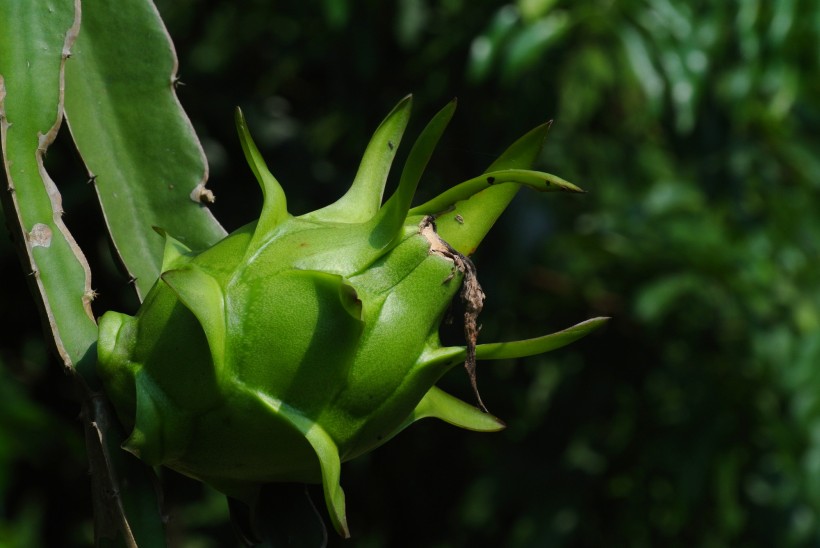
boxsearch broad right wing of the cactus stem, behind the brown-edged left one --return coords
[65,0,225,299]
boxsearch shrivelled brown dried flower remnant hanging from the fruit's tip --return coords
[419,215,489,413]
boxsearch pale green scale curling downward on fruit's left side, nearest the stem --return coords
[160,267,227,372]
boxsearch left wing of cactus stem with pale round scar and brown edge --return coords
[0,1,92,371]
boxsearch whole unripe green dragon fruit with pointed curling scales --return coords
[98,97,608,536]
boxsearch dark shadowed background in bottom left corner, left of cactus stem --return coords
[0,230,91,548]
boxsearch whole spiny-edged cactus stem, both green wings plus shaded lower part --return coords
[0,0,232,546]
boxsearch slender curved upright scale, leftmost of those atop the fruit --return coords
[235,107,289,248]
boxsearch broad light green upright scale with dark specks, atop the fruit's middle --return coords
[303,95,413,223]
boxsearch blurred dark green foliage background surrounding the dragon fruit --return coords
[0,0,820,547]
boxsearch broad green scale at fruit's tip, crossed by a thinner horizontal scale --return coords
[436,123,550,255]
